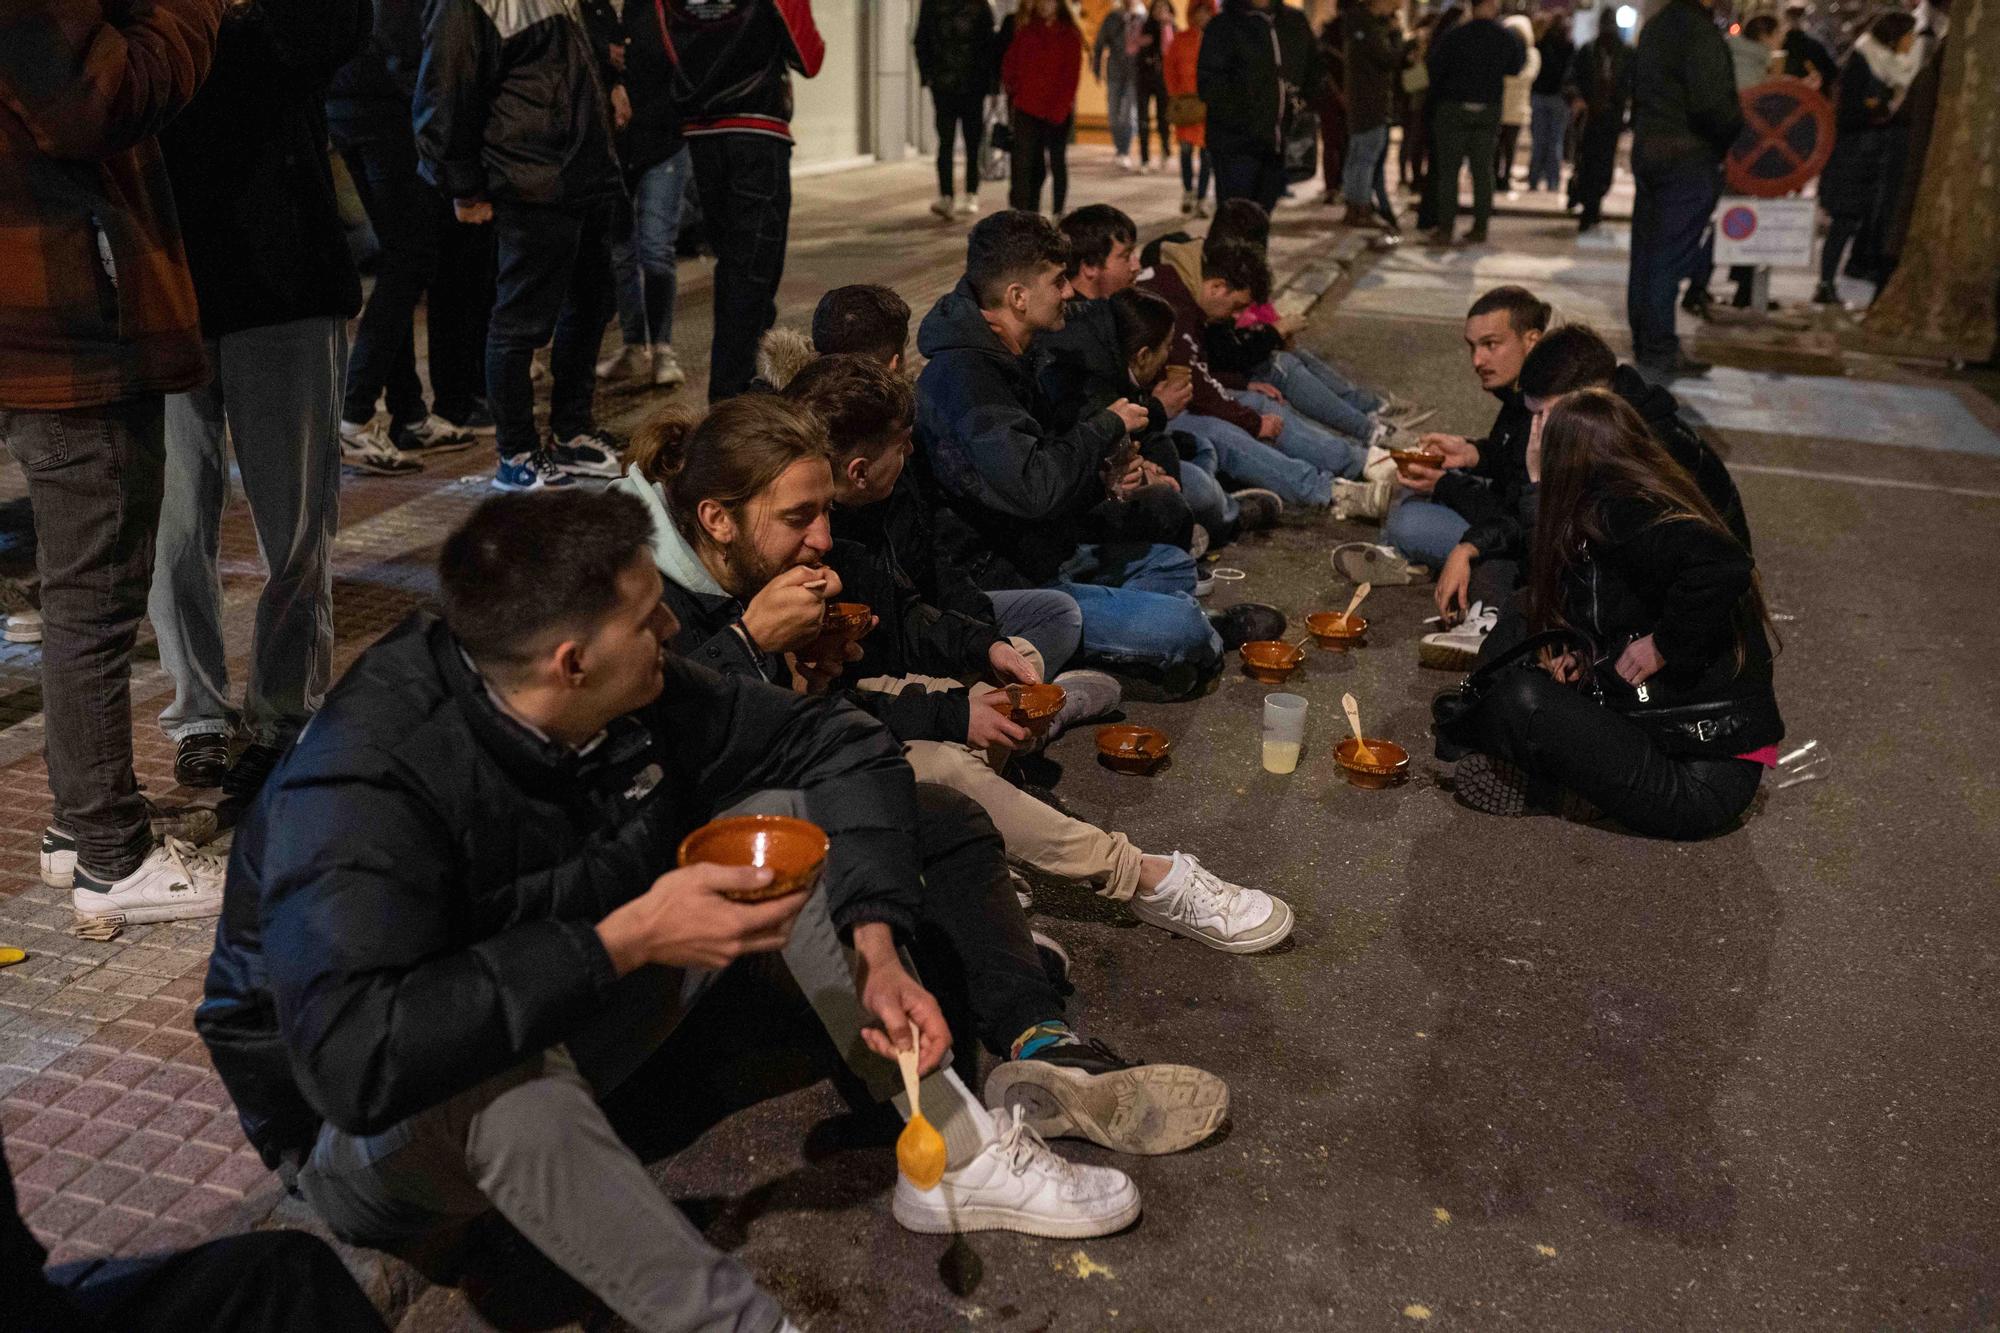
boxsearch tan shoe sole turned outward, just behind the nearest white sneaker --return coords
[986,1061,1230,1157]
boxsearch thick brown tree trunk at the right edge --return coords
[1862,0,2000,360]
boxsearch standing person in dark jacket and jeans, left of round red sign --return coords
[1626,0,1744,376]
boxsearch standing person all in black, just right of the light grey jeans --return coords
[326,0,494,474]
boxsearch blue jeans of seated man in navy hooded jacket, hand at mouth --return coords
[1048,544,1222,671]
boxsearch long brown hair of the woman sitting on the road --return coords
[1528,388,1778,671]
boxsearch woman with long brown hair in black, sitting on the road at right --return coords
[1454,388,1784,839]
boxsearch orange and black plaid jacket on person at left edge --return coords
[0,0,224,410]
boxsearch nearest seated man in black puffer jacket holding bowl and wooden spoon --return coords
[207,490,1186,1333]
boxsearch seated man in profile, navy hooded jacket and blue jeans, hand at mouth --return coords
[916,210,1222,697]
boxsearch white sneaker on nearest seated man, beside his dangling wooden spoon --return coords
[890,1107,1140,1241]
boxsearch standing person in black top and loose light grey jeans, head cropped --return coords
[148,0,370,799]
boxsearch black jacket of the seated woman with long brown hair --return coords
[1562,498,1784,759]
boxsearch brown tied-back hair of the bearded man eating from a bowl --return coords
[626,394,832,546]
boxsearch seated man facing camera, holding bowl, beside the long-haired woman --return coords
[1334,286,1550,671]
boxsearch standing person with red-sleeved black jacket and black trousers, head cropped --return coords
[664,0,826,402]
